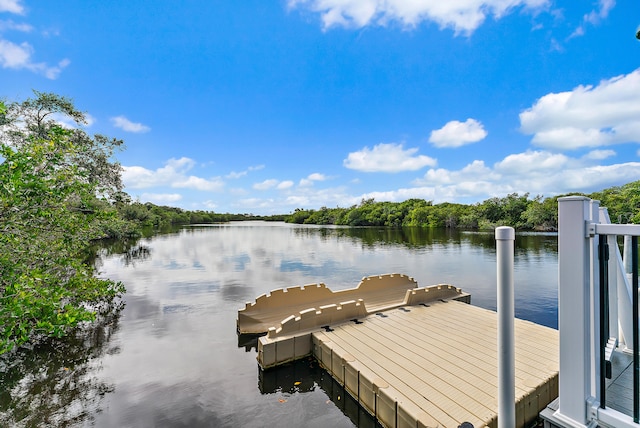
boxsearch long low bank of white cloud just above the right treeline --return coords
[225,150,640,213]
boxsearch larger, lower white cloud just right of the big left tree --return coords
[122,157,224,192]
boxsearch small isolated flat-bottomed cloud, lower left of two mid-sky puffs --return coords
[343,143,437,172]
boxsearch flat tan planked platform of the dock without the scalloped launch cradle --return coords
[312,301,558,428]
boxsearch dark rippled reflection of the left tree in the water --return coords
[0,303,124,427]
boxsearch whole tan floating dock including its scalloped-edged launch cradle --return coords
[238,274,559,428]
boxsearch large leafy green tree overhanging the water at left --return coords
[0,93,128,354]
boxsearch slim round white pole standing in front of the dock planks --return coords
[496,226,516,427]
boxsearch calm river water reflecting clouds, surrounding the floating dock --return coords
[0,222,557,428]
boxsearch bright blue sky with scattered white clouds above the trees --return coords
[0,0,640,214]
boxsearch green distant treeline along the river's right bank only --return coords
[286,181,640,231]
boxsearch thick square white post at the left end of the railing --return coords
[557,196,592,425]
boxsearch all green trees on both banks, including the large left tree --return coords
[0,91,640,355]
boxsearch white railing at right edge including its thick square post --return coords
[553,196,640,427]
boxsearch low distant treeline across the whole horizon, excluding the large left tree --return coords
[105,180,640,231]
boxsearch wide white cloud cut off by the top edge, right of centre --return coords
[288,0,549,34]
